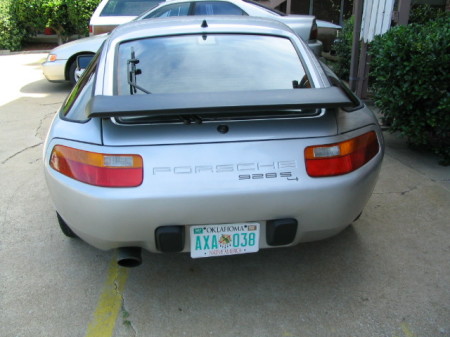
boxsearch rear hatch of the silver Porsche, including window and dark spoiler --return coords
[88,31,353,146]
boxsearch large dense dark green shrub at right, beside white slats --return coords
[370,14,450,165]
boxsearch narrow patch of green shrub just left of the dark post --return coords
[332,17,355,80]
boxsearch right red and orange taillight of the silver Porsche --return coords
[305,131,380,177]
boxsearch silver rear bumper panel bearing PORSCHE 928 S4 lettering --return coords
[45,127,383,252]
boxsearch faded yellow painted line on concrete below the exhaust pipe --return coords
[85,257,128,337]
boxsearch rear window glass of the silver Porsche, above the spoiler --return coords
[116,34,306,95]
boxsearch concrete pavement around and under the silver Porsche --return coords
[0,54,450,337]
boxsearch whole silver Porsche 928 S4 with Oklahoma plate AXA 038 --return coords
[44,16,384,267]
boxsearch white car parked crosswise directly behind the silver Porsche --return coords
[42,0,322,83]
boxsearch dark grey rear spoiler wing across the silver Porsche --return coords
[86,87,354,118]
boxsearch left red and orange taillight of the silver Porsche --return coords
[50,145,144,187]
